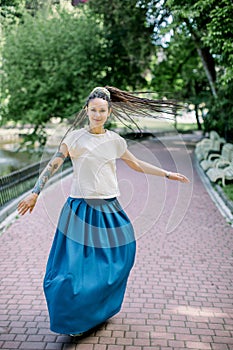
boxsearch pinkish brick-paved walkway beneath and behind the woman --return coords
[0,138,233,350]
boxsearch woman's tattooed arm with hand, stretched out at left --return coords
[18,143,69,215]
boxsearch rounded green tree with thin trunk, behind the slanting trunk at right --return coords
[151,31,209,130]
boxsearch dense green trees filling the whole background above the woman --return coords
[1,0,233,144]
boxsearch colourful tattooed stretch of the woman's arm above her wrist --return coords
[32,152,66,194]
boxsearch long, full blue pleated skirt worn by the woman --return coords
[44,197,136,334]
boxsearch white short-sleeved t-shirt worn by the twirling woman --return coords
[62,128,127,198]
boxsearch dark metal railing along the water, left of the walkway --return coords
[0,159,71,207]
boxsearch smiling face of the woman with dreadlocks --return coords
[87,98,111,128]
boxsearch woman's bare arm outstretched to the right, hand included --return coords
[121,150,190,183]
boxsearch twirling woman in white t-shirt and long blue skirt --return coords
[18,87,189,336]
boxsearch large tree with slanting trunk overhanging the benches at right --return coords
[140,0,233,140]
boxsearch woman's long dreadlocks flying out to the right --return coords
[61,86,181,143]
